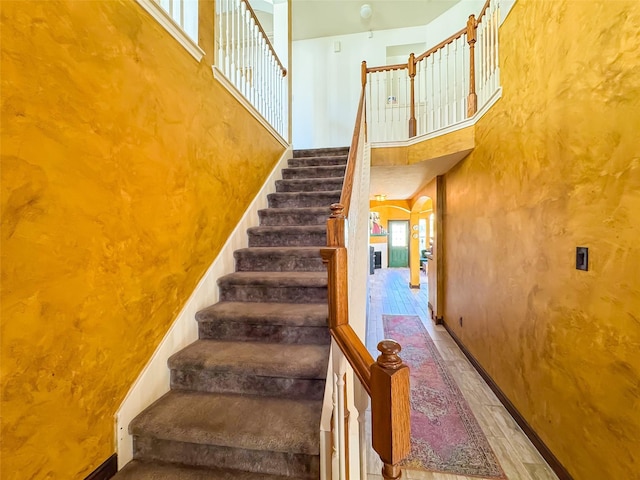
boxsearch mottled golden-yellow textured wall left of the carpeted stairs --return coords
[0,0,284,480]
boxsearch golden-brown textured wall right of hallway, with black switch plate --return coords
[445,0,640,480]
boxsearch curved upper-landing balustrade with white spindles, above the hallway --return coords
[366,0,500,142]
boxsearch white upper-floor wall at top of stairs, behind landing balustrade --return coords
[292,0,514,148]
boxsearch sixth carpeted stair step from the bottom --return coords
[233,247,325,272]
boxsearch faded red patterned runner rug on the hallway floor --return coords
[382,315,506,479]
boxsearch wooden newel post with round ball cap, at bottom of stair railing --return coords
[371,340,411,480]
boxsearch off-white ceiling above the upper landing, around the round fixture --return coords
[291,0,460,40]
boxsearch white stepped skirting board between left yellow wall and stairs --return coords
[115,148,292,469]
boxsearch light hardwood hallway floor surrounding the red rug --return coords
[366,268,558,480]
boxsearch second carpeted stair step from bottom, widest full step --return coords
[129,391,322,479]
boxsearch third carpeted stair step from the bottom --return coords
[169,340,329,400]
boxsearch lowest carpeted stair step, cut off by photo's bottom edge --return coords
[113,460,291,480]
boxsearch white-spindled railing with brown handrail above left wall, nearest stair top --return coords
[215,0,289,139]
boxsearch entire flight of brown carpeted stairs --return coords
[114,148,348,480]
